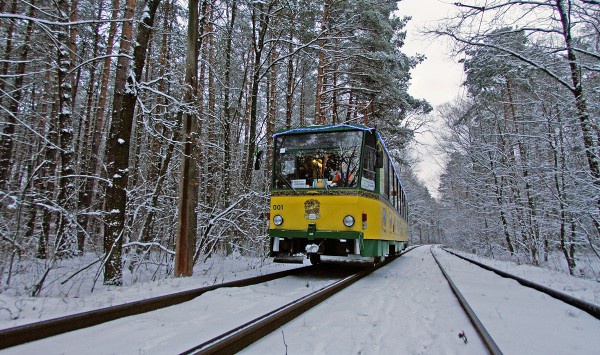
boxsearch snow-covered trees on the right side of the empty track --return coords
[433,0,600,279]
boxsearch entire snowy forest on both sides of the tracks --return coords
[0,0,600,296]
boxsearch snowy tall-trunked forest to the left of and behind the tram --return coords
[0,0,430,294]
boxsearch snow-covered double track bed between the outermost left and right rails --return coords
[0,247,600,354]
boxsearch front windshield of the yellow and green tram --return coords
[273,131,363,189]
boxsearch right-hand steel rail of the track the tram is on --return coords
[182,247,415,355]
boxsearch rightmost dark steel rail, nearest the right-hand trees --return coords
[442,248,600,319]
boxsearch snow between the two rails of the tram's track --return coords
[7,276,332,354]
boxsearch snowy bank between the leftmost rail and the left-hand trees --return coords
[0,254,302,329]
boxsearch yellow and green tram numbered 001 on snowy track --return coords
[269,124,408,264]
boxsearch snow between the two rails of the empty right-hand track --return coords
[434,248,600,354]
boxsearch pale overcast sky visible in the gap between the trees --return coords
[398,0,463,196]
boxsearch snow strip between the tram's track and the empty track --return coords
[243,247,487,354]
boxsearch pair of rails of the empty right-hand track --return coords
[430,247,600,354]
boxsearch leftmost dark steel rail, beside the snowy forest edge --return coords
[0,266,315,349]
